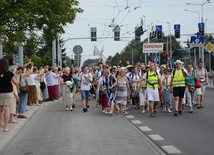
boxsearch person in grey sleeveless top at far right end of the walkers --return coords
[194,60,209,109]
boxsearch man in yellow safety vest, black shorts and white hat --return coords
[170,60,187,116]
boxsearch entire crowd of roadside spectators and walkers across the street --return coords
[0,58,208,131]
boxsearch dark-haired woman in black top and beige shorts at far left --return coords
[0,58,19,132]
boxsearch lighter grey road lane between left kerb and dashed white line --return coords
[0,95,164,155]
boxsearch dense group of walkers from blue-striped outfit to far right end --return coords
[89,60,209,117]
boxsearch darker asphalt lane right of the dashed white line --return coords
[123,88,214,155]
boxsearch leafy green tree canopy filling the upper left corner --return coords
[0,0,83,43]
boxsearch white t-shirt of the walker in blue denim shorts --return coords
[78,73,92,90]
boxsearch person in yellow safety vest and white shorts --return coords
[143,63,162,117]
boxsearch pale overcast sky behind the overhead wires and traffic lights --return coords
[61,0,214,61]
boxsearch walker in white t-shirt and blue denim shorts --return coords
[78,66,92,112]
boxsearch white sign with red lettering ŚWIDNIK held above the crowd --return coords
[143,43,163,53]
